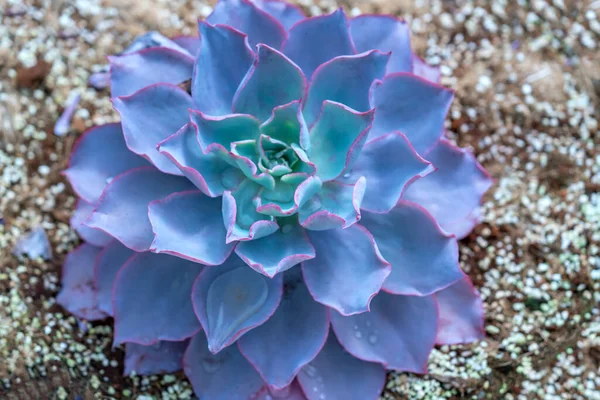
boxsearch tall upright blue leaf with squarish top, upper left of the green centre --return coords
[192,21,254,116]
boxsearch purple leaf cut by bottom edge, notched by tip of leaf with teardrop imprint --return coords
[183,330,264,400]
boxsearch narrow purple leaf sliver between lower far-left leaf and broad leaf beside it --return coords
[94,240,136,317]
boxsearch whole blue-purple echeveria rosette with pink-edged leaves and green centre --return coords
[58,0,491,400]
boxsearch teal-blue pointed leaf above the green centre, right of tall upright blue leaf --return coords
[233,44,306,121]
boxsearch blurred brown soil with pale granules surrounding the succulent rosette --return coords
[0,0,600,400]
